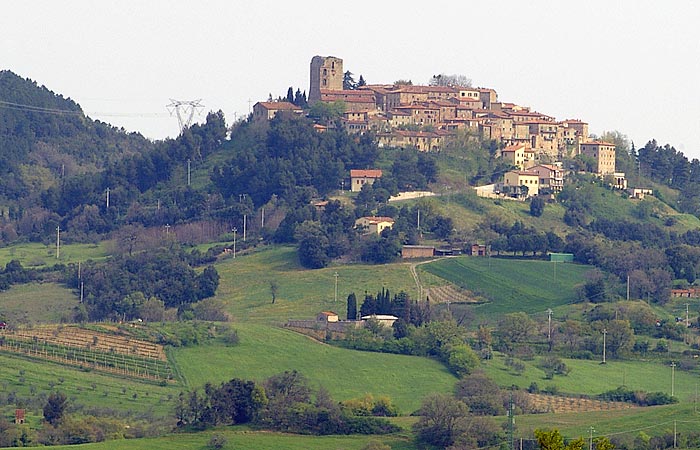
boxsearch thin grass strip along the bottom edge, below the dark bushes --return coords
[54,427,417,450]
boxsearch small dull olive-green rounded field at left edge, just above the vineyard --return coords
[0,283,79,323]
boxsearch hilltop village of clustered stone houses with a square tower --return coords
[253,56,636,199]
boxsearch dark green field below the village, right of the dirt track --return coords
[418,256,592,320]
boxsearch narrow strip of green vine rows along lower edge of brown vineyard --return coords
[0,337,173,380]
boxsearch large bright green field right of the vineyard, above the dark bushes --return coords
[171,323,457,414]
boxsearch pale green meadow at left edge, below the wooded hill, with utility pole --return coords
[0,241,112,267]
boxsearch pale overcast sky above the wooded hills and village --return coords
[0,0,700,158]
